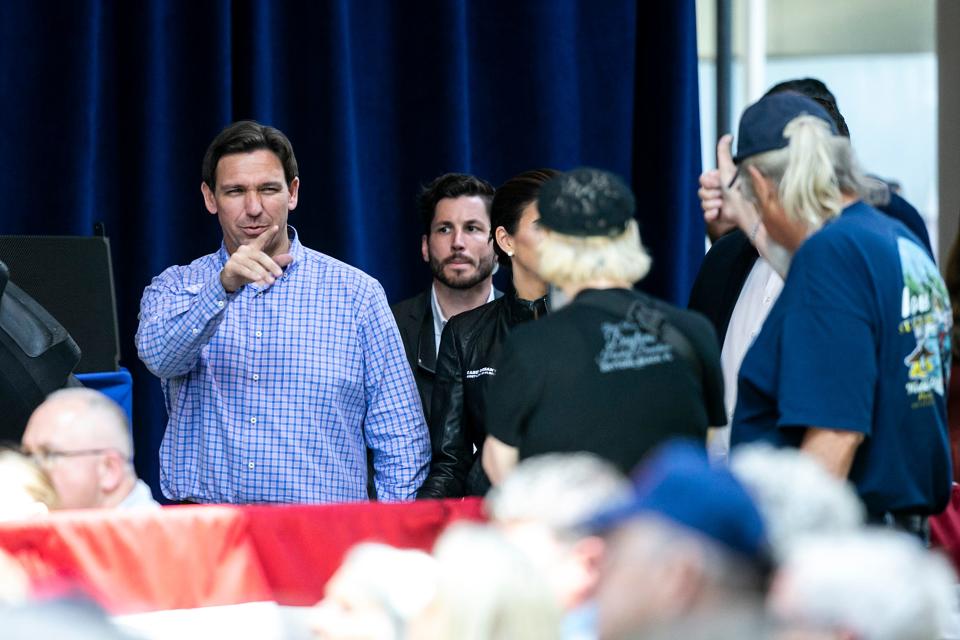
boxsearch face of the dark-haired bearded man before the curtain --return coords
[421,196,495,289]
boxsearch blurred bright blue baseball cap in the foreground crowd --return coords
[584,440,767,560]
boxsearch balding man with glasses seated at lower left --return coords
[22,388,158,509]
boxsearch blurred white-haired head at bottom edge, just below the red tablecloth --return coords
[310,543,437,640]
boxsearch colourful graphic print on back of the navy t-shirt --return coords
[897,238,953,408]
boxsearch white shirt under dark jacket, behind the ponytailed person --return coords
[708,258,783,460]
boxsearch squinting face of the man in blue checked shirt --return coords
[200,149,300,256]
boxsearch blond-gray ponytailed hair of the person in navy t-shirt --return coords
[740,114,868,230]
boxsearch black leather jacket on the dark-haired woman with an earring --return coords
[417,292,547,498]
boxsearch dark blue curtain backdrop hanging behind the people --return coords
[0,0,703,498]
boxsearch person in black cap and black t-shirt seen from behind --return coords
[483,168,726,483]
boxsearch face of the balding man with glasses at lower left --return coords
[22,407,105,509]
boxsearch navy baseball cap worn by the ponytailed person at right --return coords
[733,91,839,164]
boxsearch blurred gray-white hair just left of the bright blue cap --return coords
[486,453,630,536]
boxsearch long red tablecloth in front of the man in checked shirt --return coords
[0,499,483,613]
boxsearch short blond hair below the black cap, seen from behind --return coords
[537,220,651,287]
